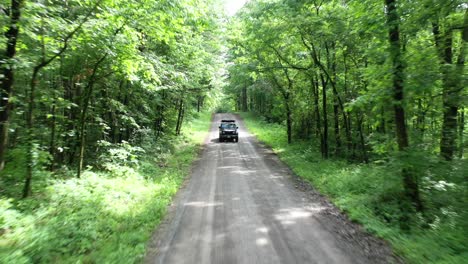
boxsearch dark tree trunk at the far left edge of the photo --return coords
[0,0,24,171]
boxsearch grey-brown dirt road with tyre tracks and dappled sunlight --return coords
[145,114,395,264]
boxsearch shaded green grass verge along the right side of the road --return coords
[240,113,468,264]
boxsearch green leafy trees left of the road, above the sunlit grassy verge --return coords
[0,0,220,197]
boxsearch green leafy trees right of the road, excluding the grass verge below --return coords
[227,0,468,225]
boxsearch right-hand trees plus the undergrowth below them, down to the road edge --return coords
[226,0,468,263]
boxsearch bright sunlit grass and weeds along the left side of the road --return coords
[0,113,211,264]
